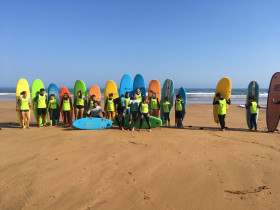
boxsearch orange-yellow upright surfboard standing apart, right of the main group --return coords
[213,77,231,123]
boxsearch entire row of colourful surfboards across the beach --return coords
[16,72,280,132]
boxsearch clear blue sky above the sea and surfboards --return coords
[0,0,280,88]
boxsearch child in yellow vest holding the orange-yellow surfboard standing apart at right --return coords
[213,93,230,131]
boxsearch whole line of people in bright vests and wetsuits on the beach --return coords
[16,88,280,131]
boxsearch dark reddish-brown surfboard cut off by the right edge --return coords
[266,72,280,132]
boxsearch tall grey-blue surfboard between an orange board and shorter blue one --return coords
[160,79,174,121]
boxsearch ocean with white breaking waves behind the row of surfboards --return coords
[0,87,268,105]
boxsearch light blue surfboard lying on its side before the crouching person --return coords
[73,117,113,130]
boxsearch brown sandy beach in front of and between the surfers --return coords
[0,102,280,210]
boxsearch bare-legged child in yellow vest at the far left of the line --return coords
[16,91,31,129]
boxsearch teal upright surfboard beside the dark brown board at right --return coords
[246,81,259,128]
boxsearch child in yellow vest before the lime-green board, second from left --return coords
[33,88,48,128]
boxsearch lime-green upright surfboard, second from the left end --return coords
[31,79,48,126]
